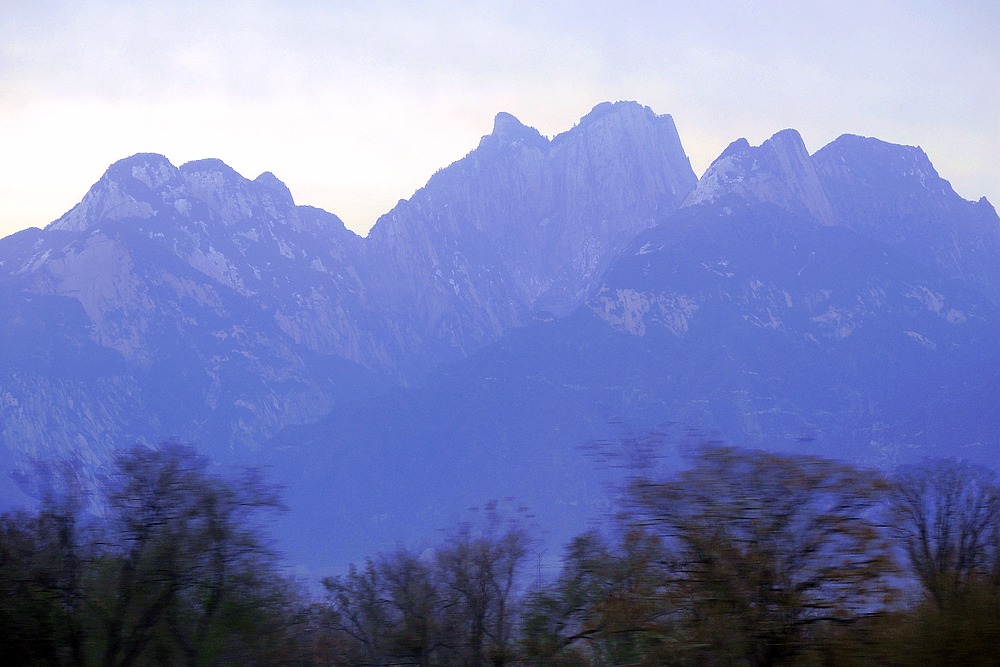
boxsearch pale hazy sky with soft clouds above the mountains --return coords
[0,0,1000,236]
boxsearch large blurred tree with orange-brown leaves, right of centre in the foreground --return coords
[630,446,894,665]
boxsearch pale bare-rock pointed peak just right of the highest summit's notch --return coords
[683,129,834,225]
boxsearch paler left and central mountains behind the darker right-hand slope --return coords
[0,103,695,458]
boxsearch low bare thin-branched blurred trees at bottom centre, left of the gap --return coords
[323,504,529,665]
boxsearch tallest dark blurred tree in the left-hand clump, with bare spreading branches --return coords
[92,443,280,667]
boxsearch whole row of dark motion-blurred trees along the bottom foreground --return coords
[0,445,1000,666]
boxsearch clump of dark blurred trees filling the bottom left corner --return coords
[0,444,290,665]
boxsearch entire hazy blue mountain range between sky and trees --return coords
[0,102,1000,568]
